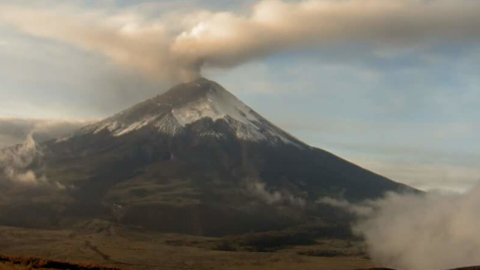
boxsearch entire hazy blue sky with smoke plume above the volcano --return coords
[0,0,480,191]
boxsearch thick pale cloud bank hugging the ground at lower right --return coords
[319,186,480,269]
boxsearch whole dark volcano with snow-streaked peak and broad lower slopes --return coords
[0,78,415,235]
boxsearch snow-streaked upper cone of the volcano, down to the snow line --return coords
[71,78,304,147]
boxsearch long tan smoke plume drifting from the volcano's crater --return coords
[0,0,480,82]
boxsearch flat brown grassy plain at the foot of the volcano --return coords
[0,222,373,270]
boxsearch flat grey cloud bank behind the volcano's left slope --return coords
[0,118,91,149]
